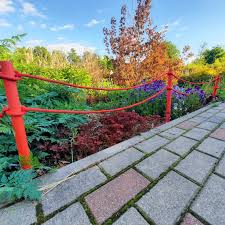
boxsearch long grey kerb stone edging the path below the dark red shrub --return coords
[39,136,145,185]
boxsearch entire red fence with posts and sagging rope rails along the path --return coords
[0,61,221,169]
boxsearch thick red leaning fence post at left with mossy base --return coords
[0,61,32,169]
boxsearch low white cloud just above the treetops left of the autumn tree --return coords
[47,42,96,55]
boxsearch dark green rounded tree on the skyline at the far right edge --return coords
[202,46,225,64]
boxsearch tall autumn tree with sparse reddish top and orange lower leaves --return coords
[103,0,183,85]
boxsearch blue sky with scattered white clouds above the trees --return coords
[0,0,225,54]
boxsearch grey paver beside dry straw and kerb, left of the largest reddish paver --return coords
[41,166,106,215]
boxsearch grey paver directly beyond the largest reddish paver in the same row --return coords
[136,149,179,179]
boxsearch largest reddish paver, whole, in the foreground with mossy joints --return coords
[85,169,149,224]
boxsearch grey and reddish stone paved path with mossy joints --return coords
[0,103,225,225]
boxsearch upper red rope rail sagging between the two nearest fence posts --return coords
[16,72,155,91]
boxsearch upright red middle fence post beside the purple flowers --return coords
[166,70,173,123]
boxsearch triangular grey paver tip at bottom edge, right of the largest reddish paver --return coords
[113,207,149,225]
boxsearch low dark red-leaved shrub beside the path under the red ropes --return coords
[75,112,163,157]
